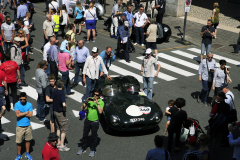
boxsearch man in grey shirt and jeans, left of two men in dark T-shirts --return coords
[35,60,48,122]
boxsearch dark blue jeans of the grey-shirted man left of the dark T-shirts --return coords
[36,93,45,121]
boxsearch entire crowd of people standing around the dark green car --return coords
[0,0,240,160]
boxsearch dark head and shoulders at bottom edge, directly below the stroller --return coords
[183,136,203,160]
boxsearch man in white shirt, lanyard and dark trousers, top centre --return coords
[132,6,148,46]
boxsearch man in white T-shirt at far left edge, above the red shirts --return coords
[1,16,15,53]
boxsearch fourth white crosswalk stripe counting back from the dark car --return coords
[158,53,199,70]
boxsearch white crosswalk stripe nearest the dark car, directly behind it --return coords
[111,64,157,84]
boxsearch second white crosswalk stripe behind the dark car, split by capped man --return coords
[119,60,177,81]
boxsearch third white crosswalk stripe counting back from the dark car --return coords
[137,56,195,77]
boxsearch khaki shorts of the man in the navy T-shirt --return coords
[54,111,68,133]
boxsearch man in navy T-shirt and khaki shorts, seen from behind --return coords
[52,80,70,151]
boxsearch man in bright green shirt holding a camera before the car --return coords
[77,88,104,157]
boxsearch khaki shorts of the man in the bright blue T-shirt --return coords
[16,125,32,143]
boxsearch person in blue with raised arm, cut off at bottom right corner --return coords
[228,122,240,160]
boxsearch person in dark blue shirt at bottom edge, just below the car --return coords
[146,135,171,160]
